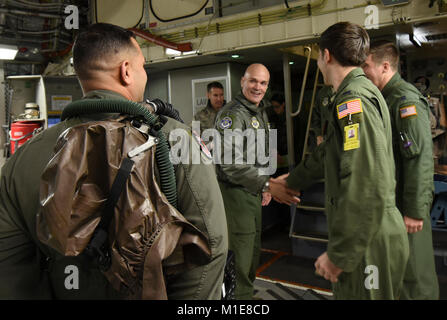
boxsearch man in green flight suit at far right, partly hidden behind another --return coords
[363,40,439,300]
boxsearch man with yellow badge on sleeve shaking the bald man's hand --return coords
[274,22,409,299]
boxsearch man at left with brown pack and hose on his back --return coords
[0,23,228,299]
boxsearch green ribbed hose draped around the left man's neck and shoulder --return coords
[61,99,177,208]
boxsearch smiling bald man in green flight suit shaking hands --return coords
[215,63,298,300]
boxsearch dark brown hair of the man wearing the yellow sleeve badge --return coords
[319,22,369,67]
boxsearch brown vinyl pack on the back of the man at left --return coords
[37,117,210,299]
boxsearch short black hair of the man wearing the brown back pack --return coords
[73,23,135,79]
